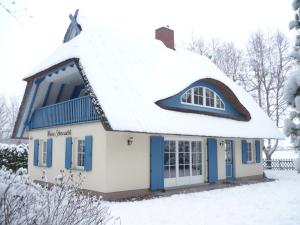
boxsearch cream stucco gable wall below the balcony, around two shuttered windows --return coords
[28,122,106,192]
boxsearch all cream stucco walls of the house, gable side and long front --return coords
[28,122,263,193]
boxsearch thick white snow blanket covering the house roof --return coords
[24,16,283,138]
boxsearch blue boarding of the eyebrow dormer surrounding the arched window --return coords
[159,80,241,117]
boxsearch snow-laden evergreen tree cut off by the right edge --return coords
[284,0,300,172]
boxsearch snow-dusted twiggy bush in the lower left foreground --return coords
[0,167,112,225]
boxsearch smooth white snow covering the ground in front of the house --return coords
[105,171,300,225]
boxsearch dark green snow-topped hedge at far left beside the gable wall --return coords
[0,144,28,171]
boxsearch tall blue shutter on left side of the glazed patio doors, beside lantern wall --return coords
[150,136,164,191]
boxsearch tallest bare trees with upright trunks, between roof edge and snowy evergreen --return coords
[244,31,290,160]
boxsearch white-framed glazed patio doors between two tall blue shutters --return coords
[164,139,204,188]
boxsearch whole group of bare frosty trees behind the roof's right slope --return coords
[188,31,290,159]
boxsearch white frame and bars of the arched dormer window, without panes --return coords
[180,86,226,111]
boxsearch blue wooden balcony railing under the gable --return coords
[29,96,100,129]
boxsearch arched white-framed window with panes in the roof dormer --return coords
[181,86,225,110]
